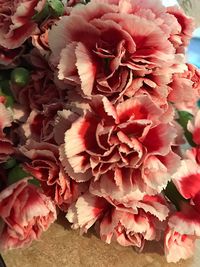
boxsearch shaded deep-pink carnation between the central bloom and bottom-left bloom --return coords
[21,140,87,210]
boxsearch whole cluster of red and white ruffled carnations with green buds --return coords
[0,0,200,262]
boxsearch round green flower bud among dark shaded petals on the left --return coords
[11,67,30,87]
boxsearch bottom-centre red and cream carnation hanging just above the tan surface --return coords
[66,193,163,249]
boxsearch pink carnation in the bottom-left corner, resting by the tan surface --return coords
[0,179,56,250]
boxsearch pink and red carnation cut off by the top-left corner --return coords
[0,0,46,49]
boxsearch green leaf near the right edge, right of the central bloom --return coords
[177,111,196,147]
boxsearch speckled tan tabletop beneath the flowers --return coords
[3,217,200,267]
